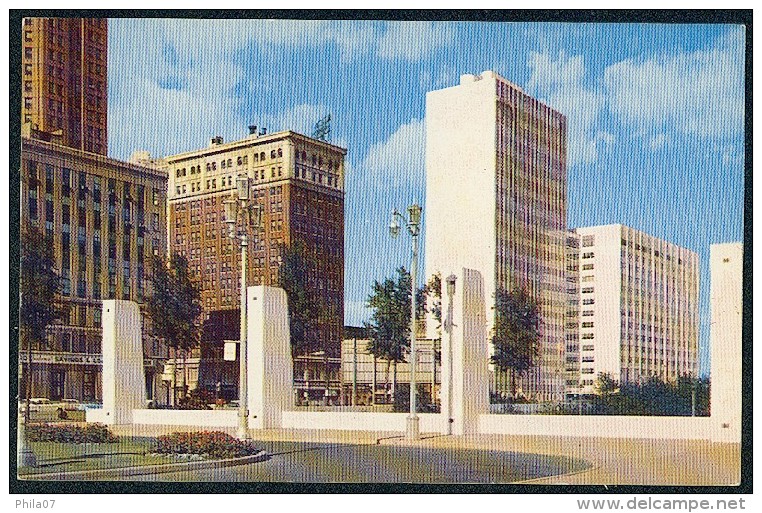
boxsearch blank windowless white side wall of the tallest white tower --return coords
[424,72,497,338]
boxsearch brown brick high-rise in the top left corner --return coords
[21,18,108,155]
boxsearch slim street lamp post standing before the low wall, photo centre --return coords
[389,203,422,440]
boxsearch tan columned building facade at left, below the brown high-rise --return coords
[19,131,167,401]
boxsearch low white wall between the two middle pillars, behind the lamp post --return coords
[282,411,445,434]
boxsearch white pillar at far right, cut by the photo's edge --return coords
[709,243,751,442]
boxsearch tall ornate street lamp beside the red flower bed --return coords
[224,176,262,440]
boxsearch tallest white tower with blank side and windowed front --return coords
[425,71,567,401]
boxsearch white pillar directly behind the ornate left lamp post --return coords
[247,286,294,429]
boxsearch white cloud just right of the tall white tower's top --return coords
[527,51,614,166]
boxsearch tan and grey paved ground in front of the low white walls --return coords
[95,426,740,486]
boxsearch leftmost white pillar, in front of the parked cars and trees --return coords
[93,299,146,424]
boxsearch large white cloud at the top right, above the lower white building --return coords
[604,29,744,138]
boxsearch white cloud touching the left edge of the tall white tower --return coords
[356,119,426,193]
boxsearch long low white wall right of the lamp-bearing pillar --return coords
[479,415,713,440]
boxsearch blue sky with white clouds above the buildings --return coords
[108,19,745,374]
